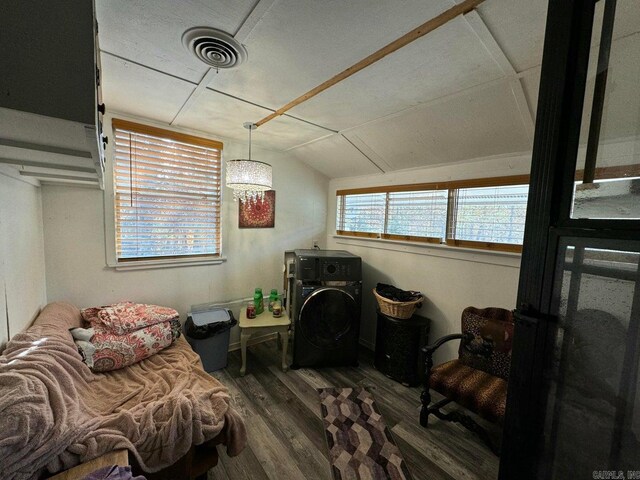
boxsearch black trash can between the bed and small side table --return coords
[184,308,238,372]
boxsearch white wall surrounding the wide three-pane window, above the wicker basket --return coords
[327,154,531,361]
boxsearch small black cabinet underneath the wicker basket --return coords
[374,310,430,387]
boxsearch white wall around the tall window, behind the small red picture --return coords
[42,119,328,343]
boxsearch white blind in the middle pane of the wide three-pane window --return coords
[386,190,448,239]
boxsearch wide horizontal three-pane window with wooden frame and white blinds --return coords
[337,175,529,252]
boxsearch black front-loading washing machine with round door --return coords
[287,250,362,369]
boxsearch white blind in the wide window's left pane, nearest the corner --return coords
[337,193,387,234]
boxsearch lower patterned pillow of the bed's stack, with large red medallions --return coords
[70,319,180,372]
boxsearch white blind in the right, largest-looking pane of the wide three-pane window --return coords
[449,185,529,245]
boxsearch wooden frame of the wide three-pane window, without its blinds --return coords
[336,175,529,253]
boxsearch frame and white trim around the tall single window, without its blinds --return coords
[104,116,226,270]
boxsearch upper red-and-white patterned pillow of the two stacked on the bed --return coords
[82,302,178,335]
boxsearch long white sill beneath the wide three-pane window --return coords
[333,235,521,268]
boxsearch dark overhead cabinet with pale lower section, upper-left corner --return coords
[0,0,106,188]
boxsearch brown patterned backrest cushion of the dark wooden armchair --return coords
[458,307,514,380]
